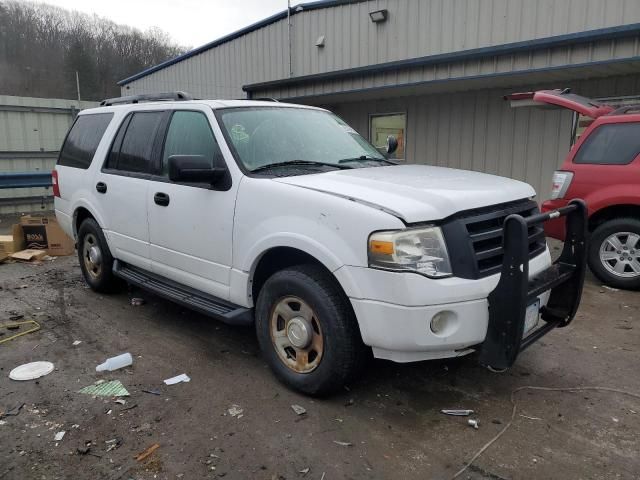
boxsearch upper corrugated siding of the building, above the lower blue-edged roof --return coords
[123,0,640,98]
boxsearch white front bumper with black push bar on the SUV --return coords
[336,202,586,368]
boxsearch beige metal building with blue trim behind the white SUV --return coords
[120,0,640,199]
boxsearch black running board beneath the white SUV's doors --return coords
[113,260,253,326]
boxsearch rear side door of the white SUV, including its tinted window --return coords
[94,111,168,270]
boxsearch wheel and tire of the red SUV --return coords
[589,218,640,290]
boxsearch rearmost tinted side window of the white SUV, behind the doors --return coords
[58,113,113,169]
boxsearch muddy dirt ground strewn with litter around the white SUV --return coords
[0,222,640,480]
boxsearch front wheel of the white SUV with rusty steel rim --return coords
[255,265,369,396]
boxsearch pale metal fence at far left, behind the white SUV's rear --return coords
[0,95,98,214]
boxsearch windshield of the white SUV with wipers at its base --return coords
[221,107,388,171]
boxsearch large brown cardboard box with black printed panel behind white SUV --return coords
[13,215,74,256]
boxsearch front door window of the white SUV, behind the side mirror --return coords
[162,110,221,176]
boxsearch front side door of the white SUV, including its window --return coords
[147,109,238,300]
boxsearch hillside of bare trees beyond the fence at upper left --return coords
[0,0,186,100]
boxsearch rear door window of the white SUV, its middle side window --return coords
[107,112,165,172]
